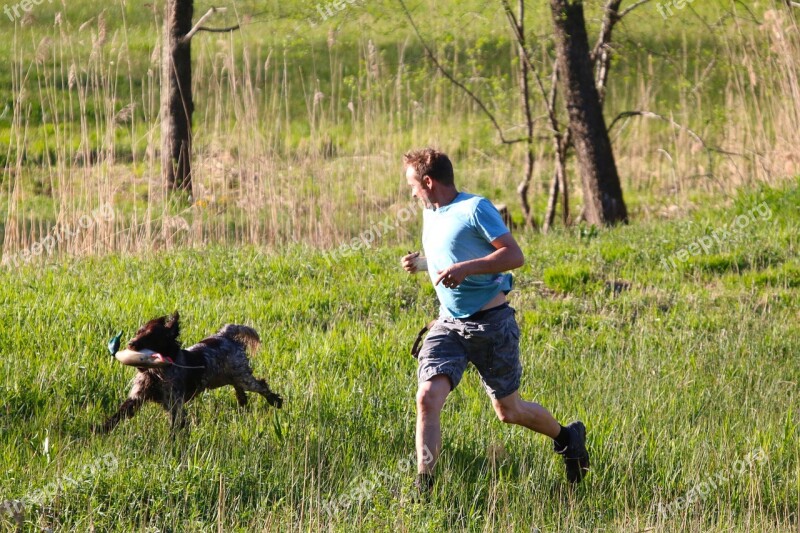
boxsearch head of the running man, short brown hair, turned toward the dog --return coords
[403,148,455,208]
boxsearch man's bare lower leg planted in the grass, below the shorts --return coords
[416,375,450,474]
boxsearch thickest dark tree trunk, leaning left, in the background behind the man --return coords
[550,0,628,225]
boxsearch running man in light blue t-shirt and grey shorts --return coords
[402,148,589,493]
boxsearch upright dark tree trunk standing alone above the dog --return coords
[161,0,194,194]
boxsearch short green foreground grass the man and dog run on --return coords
[0,181,800,531]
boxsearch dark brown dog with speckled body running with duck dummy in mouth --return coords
[101,312,283,433]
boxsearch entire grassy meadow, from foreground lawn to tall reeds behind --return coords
[0,0,800,533]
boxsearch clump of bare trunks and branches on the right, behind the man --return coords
[398,0,649,227]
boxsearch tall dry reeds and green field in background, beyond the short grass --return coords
[0,1,800,257]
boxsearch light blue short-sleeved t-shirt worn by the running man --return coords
[422,192,513,318]
